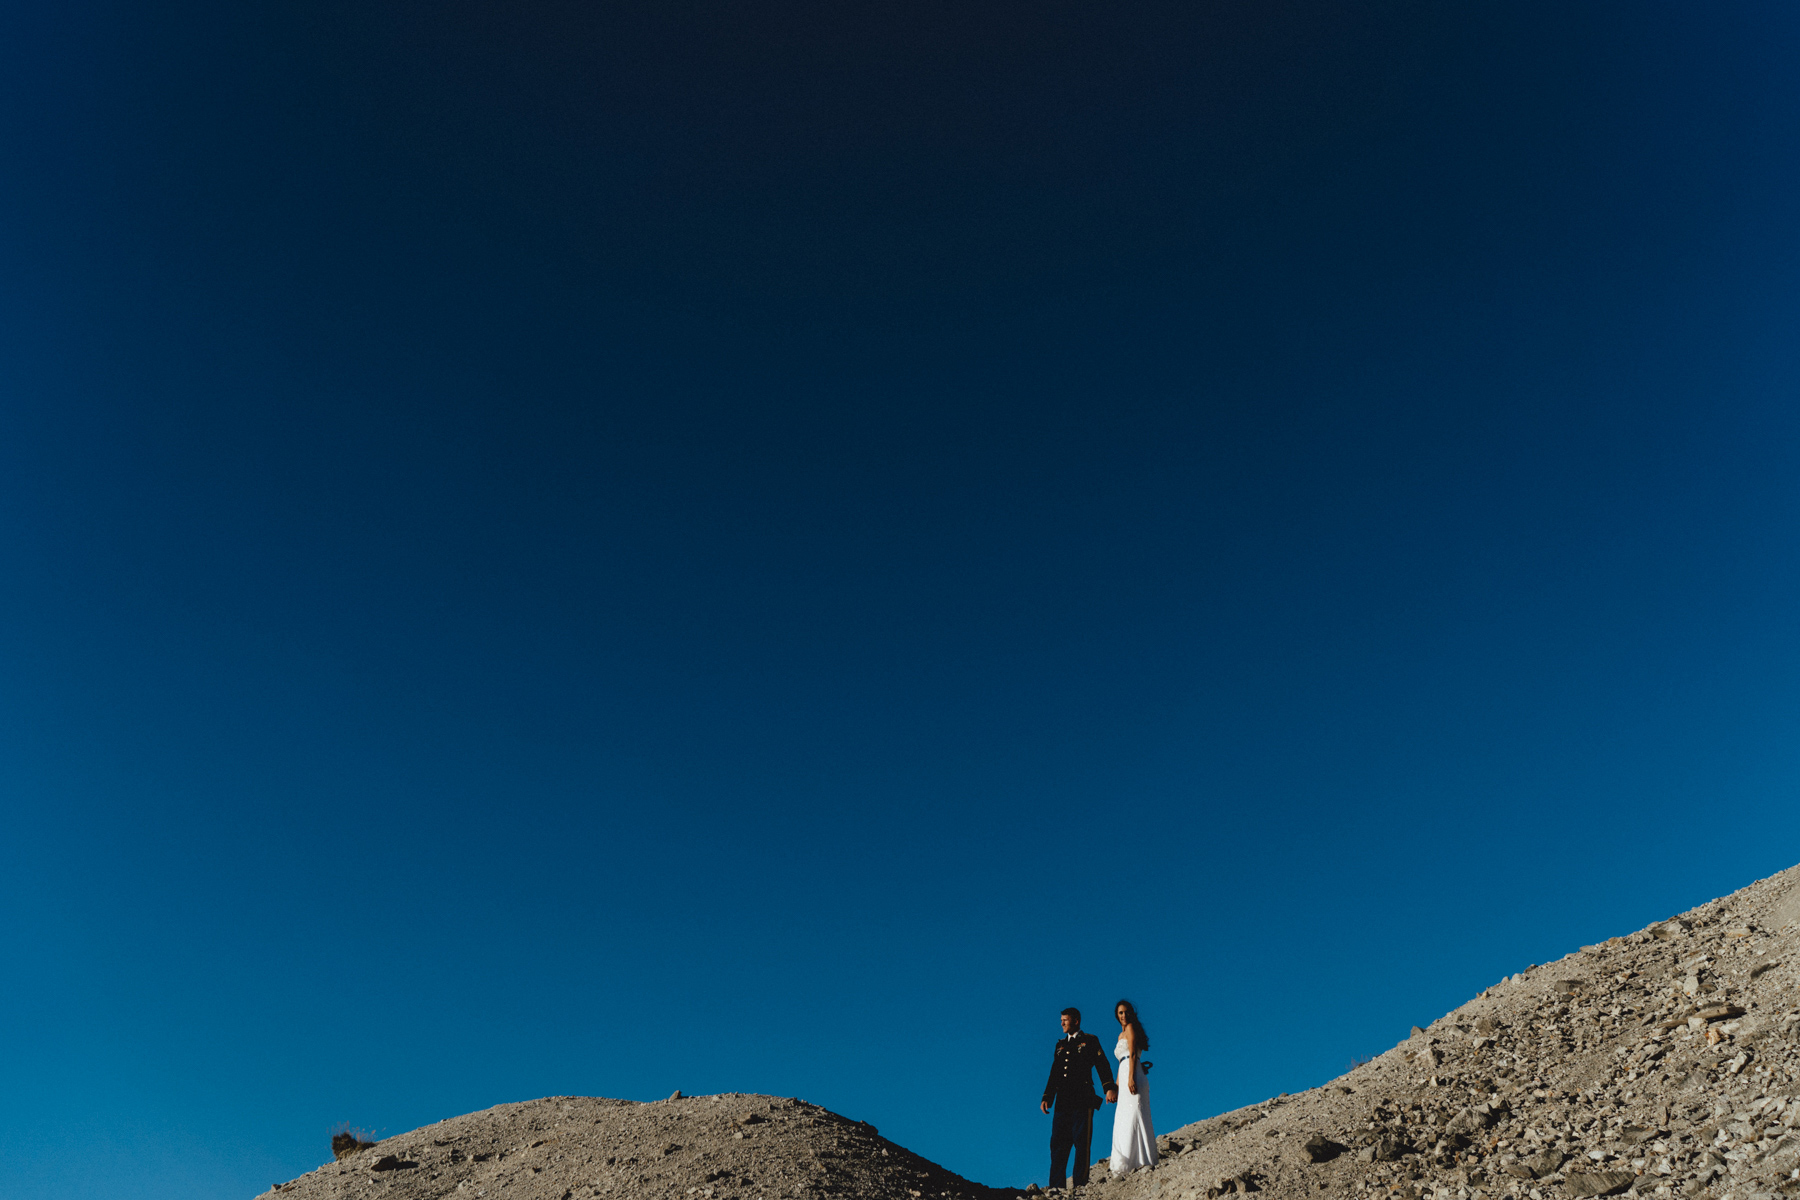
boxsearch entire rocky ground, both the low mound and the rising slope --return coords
[265,867,1800,1200]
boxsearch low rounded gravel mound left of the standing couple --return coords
[265,1096,1013,1200]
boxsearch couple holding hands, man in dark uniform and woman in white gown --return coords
[1040,1000,1156,1187]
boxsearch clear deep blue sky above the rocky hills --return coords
[0,0,1800,1200]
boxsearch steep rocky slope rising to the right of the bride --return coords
[1087,867,1800,1200]
